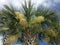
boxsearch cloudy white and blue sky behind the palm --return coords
[0,0,60,45]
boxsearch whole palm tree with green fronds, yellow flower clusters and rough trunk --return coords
[1,0,58,45]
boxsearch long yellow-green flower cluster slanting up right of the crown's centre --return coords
[29,16,44,28]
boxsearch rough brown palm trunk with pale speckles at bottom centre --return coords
[22,31,38,45]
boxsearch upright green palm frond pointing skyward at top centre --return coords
[22,0,33,21]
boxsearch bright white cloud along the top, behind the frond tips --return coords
[0,0,45,7]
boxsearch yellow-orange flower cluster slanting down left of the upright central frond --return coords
[15,12,27,27]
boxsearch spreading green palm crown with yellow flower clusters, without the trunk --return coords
[1,0,58,44]
